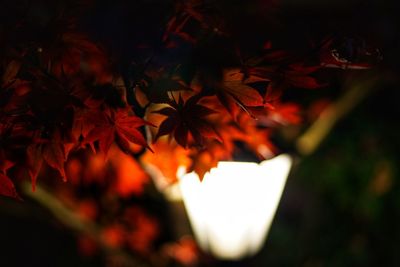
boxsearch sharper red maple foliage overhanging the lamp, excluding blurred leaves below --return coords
[0,0,379,197]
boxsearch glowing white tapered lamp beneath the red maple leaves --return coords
[180,155,292,260]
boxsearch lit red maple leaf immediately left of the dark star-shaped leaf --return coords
[84,109,153,155]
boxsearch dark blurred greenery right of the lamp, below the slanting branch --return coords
[254,86,400,267]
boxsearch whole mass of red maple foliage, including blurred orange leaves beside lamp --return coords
[0,0,381,266]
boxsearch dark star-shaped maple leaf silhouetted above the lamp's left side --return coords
[154,95,221,148]
